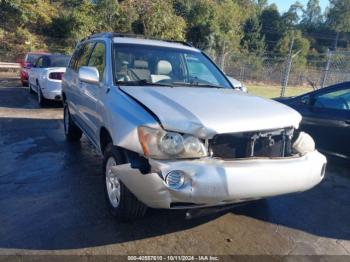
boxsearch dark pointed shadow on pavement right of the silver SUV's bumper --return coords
[232,162,350,240]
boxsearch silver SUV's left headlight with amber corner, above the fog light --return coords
[138,127,207,159]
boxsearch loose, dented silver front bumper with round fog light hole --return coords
[113,151,327,208]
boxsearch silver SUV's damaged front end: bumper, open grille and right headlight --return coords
[113,127,326,208]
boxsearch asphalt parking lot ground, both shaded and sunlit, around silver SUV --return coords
[0,79,350,255]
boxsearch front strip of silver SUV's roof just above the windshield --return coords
[113,37,200,52]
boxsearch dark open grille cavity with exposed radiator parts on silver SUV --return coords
[209,128,294,159]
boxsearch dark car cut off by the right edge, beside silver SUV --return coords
[276,82,350,159]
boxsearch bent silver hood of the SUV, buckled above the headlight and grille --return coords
[120,86,301,138]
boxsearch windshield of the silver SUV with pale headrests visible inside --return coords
[114,44,231,88]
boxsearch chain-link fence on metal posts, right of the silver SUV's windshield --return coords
[225,51,350,94]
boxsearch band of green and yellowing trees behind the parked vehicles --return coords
[0,0,350,70]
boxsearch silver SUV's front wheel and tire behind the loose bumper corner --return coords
[103,143,147,221]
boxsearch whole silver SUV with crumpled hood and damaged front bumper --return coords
[62,33,326,219]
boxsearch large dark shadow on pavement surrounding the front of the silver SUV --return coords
[0,118,350,250]
